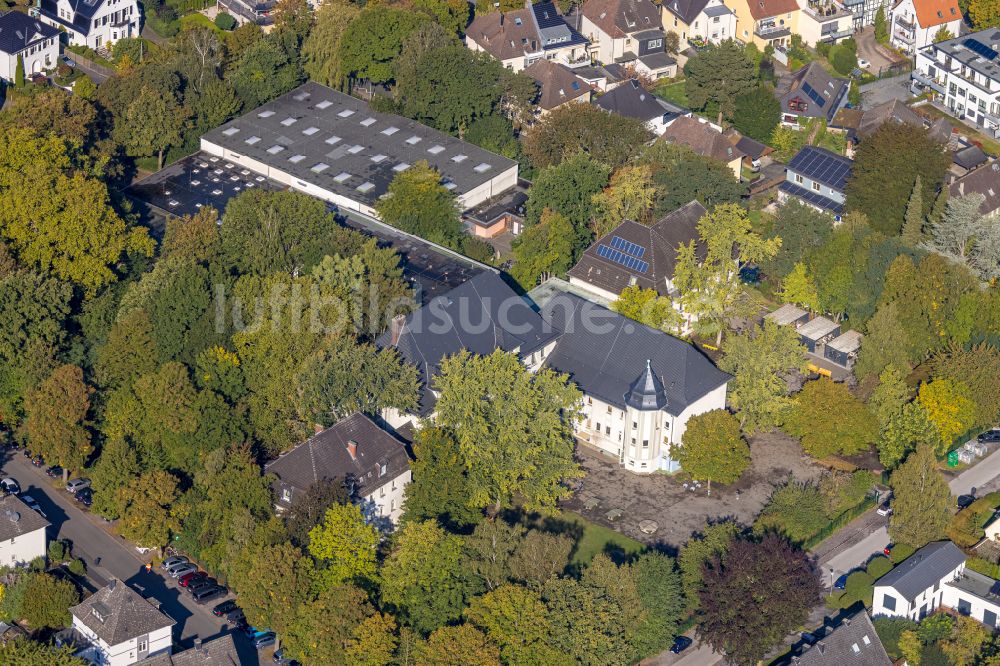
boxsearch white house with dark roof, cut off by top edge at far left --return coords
[33,0,141,49]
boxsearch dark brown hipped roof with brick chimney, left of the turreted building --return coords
[264,413,410,504]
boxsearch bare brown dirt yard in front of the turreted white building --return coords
[563,432,824,550]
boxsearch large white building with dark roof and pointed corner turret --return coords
[542,292,730,474]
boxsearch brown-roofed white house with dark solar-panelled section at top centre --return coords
[465,0,590,72]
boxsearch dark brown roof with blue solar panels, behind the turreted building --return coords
[569,201,706,296]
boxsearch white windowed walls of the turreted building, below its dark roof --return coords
[575,384,726,474]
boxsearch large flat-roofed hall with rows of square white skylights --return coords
[201,81,517,218]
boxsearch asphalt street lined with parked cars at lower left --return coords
[3,451,258,664]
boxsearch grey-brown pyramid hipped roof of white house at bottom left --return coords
[69,579,176,645]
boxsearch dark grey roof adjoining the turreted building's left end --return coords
[376,271,557,416]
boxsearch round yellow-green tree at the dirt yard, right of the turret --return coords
[676,409,750,493]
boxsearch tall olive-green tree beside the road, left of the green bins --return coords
[889,445,952,548]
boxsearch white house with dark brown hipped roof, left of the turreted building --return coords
[264,413,411,528]
